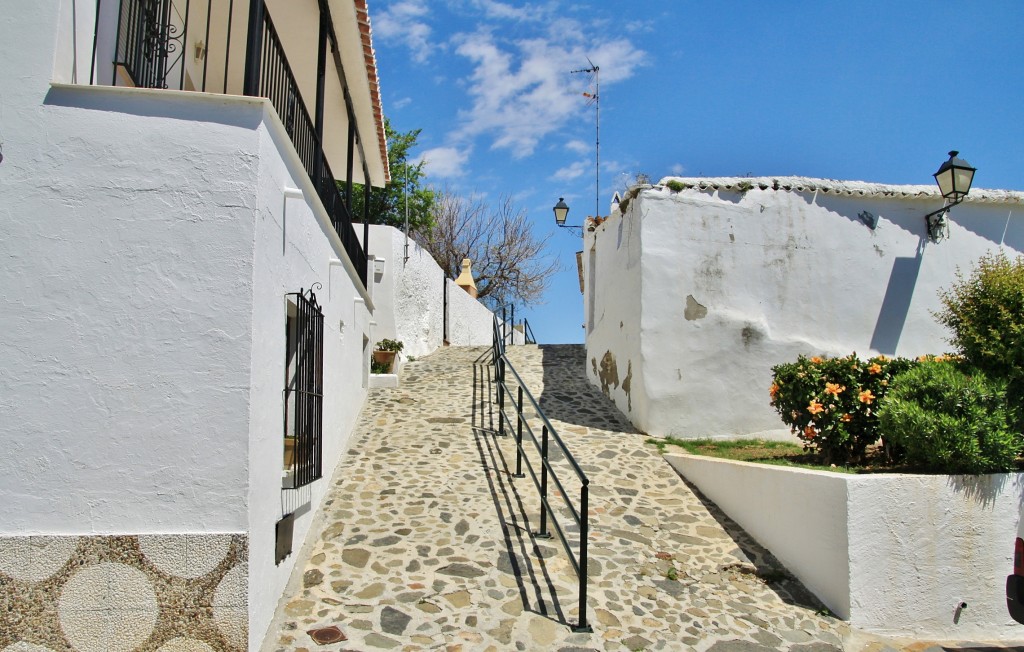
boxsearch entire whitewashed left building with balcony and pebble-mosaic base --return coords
[0,0,388,650]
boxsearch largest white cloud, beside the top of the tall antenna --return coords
[455,25,645,159]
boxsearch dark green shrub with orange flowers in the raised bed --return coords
[769,353,916,464]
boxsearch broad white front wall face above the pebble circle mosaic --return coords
[0,84,261,534]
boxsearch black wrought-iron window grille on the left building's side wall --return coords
[285,284,324,488]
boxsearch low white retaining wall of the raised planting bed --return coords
[666,454,1024,640]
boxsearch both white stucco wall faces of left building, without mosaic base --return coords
[0,5,372,649]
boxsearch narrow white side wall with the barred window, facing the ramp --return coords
[248,113,376,649]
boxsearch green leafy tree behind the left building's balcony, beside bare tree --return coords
[352,118,434,233]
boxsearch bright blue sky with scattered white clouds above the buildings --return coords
[370,0,1024,343]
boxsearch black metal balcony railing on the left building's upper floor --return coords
[107,0,367,287]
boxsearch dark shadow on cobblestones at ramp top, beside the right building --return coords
[538,344,639,434]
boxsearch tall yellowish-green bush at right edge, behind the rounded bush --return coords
[935,253,1024,430]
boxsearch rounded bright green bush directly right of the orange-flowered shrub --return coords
[879,361,1022,474]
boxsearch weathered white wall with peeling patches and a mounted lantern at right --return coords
[584,179,1024,437]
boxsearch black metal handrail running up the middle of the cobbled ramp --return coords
[492,315,592,632]
